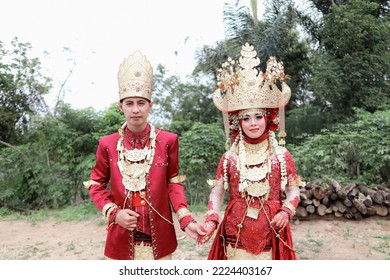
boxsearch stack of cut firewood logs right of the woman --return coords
[296,180,390,219]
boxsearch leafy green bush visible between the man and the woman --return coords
[180,123,226,204]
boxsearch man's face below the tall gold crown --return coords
[118,97,153,132]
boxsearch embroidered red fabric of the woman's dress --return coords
[208,149,298,259]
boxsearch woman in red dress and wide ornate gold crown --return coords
[198,44,302,260]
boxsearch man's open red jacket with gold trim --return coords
[89,126,188,259]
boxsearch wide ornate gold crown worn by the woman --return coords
[213,43,291,112]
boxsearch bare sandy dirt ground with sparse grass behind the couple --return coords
[0,214,390,260]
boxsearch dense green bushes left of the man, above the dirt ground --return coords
[0,104,97,211]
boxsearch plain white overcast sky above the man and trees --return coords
[0,0,233,110]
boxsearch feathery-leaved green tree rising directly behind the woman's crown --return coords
[194,0,309,107]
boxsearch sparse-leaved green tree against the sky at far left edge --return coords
[0,38,51,144]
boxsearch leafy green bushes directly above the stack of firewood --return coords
[289,110,390,184]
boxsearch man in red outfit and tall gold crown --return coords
[86,51,204,260]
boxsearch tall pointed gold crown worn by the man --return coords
[118,50,153,101]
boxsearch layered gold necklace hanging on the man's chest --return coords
[117,122,157,192]
